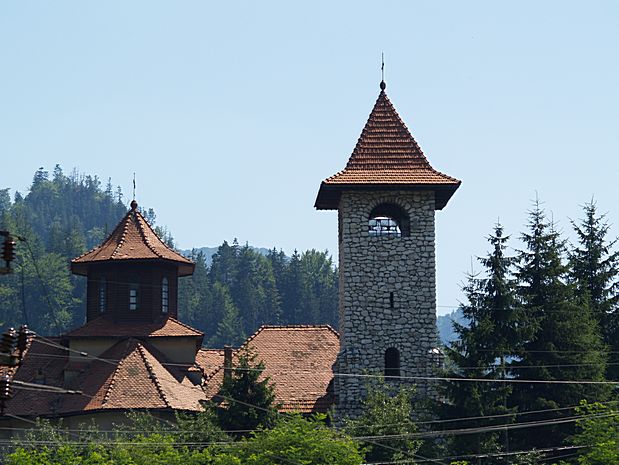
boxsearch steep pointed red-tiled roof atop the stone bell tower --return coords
[315,81,460,210]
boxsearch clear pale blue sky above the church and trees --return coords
[0,1,619,313]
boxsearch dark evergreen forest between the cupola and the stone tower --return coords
[179,240,338,347]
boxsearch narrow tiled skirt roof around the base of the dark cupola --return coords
[66,316,204,337]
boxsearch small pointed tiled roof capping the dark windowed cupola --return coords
[71,200,195,276]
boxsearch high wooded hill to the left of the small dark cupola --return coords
[0,166,125,334]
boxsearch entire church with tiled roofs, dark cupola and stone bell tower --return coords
[2,78,460,428]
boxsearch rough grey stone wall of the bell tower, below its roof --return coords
[334,191,437,418]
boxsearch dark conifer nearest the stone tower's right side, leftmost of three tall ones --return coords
[443,224,526,463]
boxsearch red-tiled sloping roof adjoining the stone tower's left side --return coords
[205,325,340,413]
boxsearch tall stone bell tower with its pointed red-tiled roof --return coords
[315,82,460,416]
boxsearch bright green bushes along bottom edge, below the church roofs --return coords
[3,412,363,465]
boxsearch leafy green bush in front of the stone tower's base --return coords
[344,380,421,463]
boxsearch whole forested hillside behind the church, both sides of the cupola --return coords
[0,166,338,346]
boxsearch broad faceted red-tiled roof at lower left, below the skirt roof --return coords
[7,338,206,416]
